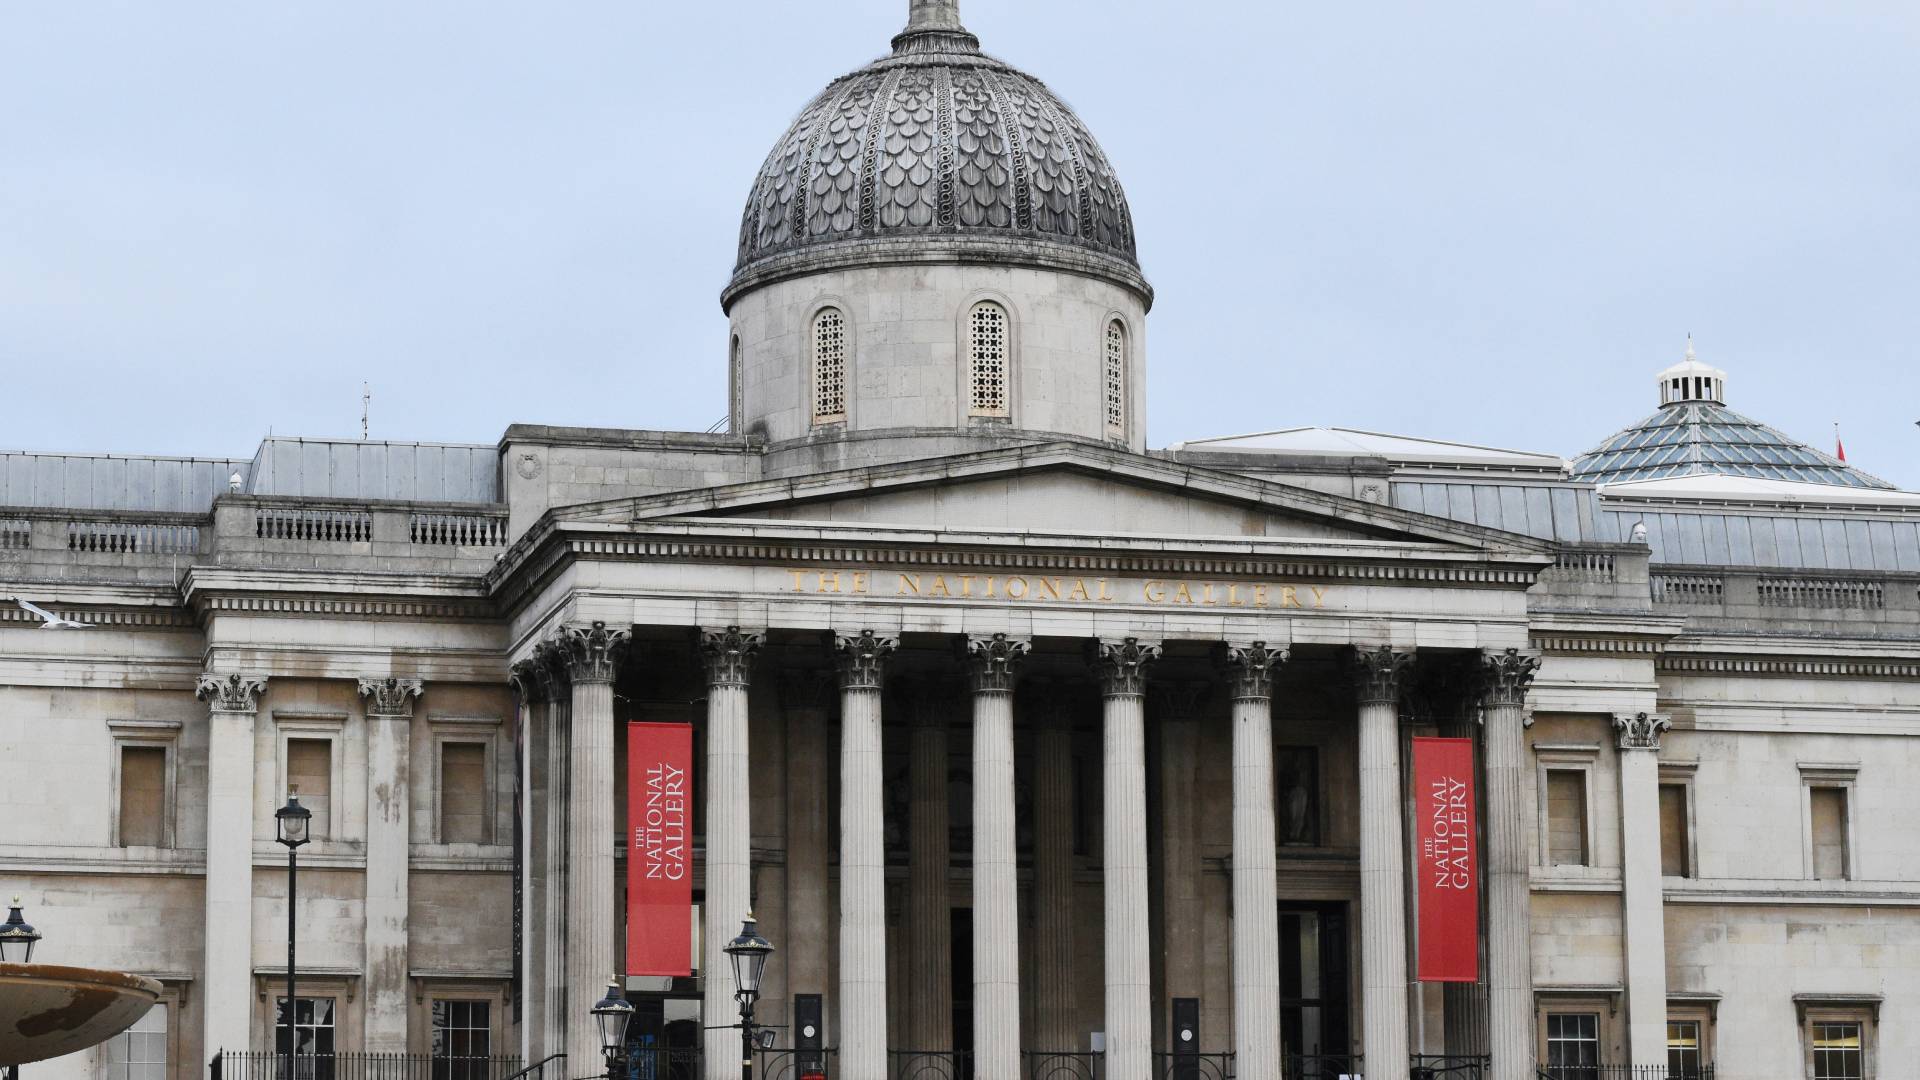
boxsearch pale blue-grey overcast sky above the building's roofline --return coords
[0,0,1920,486]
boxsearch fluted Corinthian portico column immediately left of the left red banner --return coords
[551,623,632,1055]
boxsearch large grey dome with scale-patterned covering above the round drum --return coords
[722,0,1150,307]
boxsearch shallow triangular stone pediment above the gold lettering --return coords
[555,444,1548,555]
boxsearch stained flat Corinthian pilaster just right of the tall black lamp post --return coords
[359,678,420,1053]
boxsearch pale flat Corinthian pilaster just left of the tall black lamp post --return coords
[196,673,267,1057]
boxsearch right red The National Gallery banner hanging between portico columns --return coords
[1413,738,1480,982]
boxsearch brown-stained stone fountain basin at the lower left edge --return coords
[0,965,159,1065]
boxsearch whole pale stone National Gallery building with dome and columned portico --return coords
[0,0,1920,1080]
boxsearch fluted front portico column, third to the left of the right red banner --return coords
[1092,638,1160,1080]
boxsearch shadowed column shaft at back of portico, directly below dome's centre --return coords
[906,686,954,1051]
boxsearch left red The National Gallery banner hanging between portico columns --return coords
[626,724,693,974]
